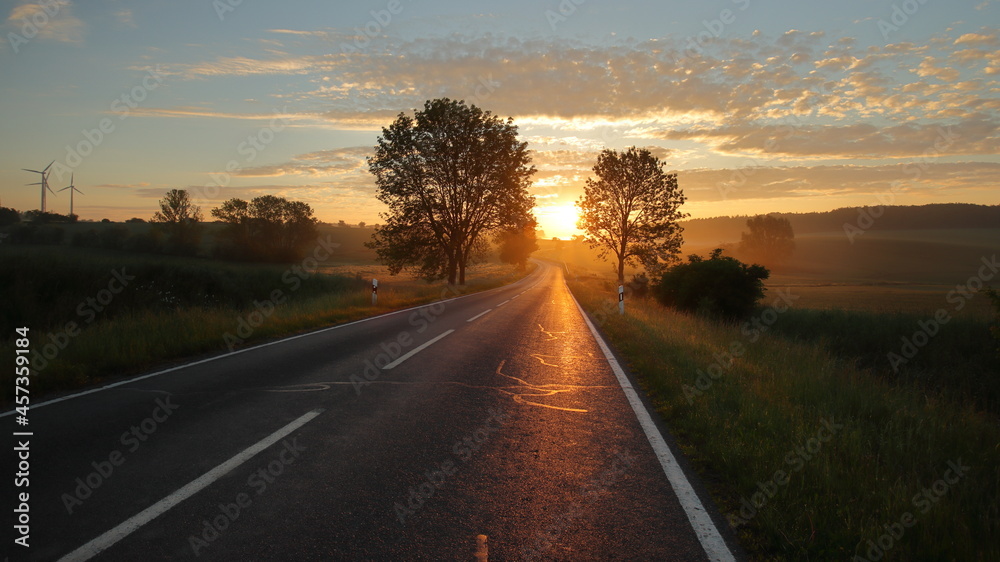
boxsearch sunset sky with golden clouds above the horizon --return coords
[0,0,1000,237]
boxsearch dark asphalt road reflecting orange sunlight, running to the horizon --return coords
[0,264,729,561]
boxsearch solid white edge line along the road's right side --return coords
[566,287,736,562]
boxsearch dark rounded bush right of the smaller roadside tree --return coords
[653,248,770,319]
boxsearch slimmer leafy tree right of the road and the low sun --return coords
[576,146,687,284]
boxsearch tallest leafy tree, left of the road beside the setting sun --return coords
[368,98,535,284]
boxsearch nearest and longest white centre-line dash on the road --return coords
[59,409,323,562]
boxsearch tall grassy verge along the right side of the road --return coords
[570,281,1000,560]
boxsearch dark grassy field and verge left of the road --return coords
[0,244,524,403]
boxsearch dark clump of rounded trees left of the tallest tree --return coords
[212,195,317,261]
